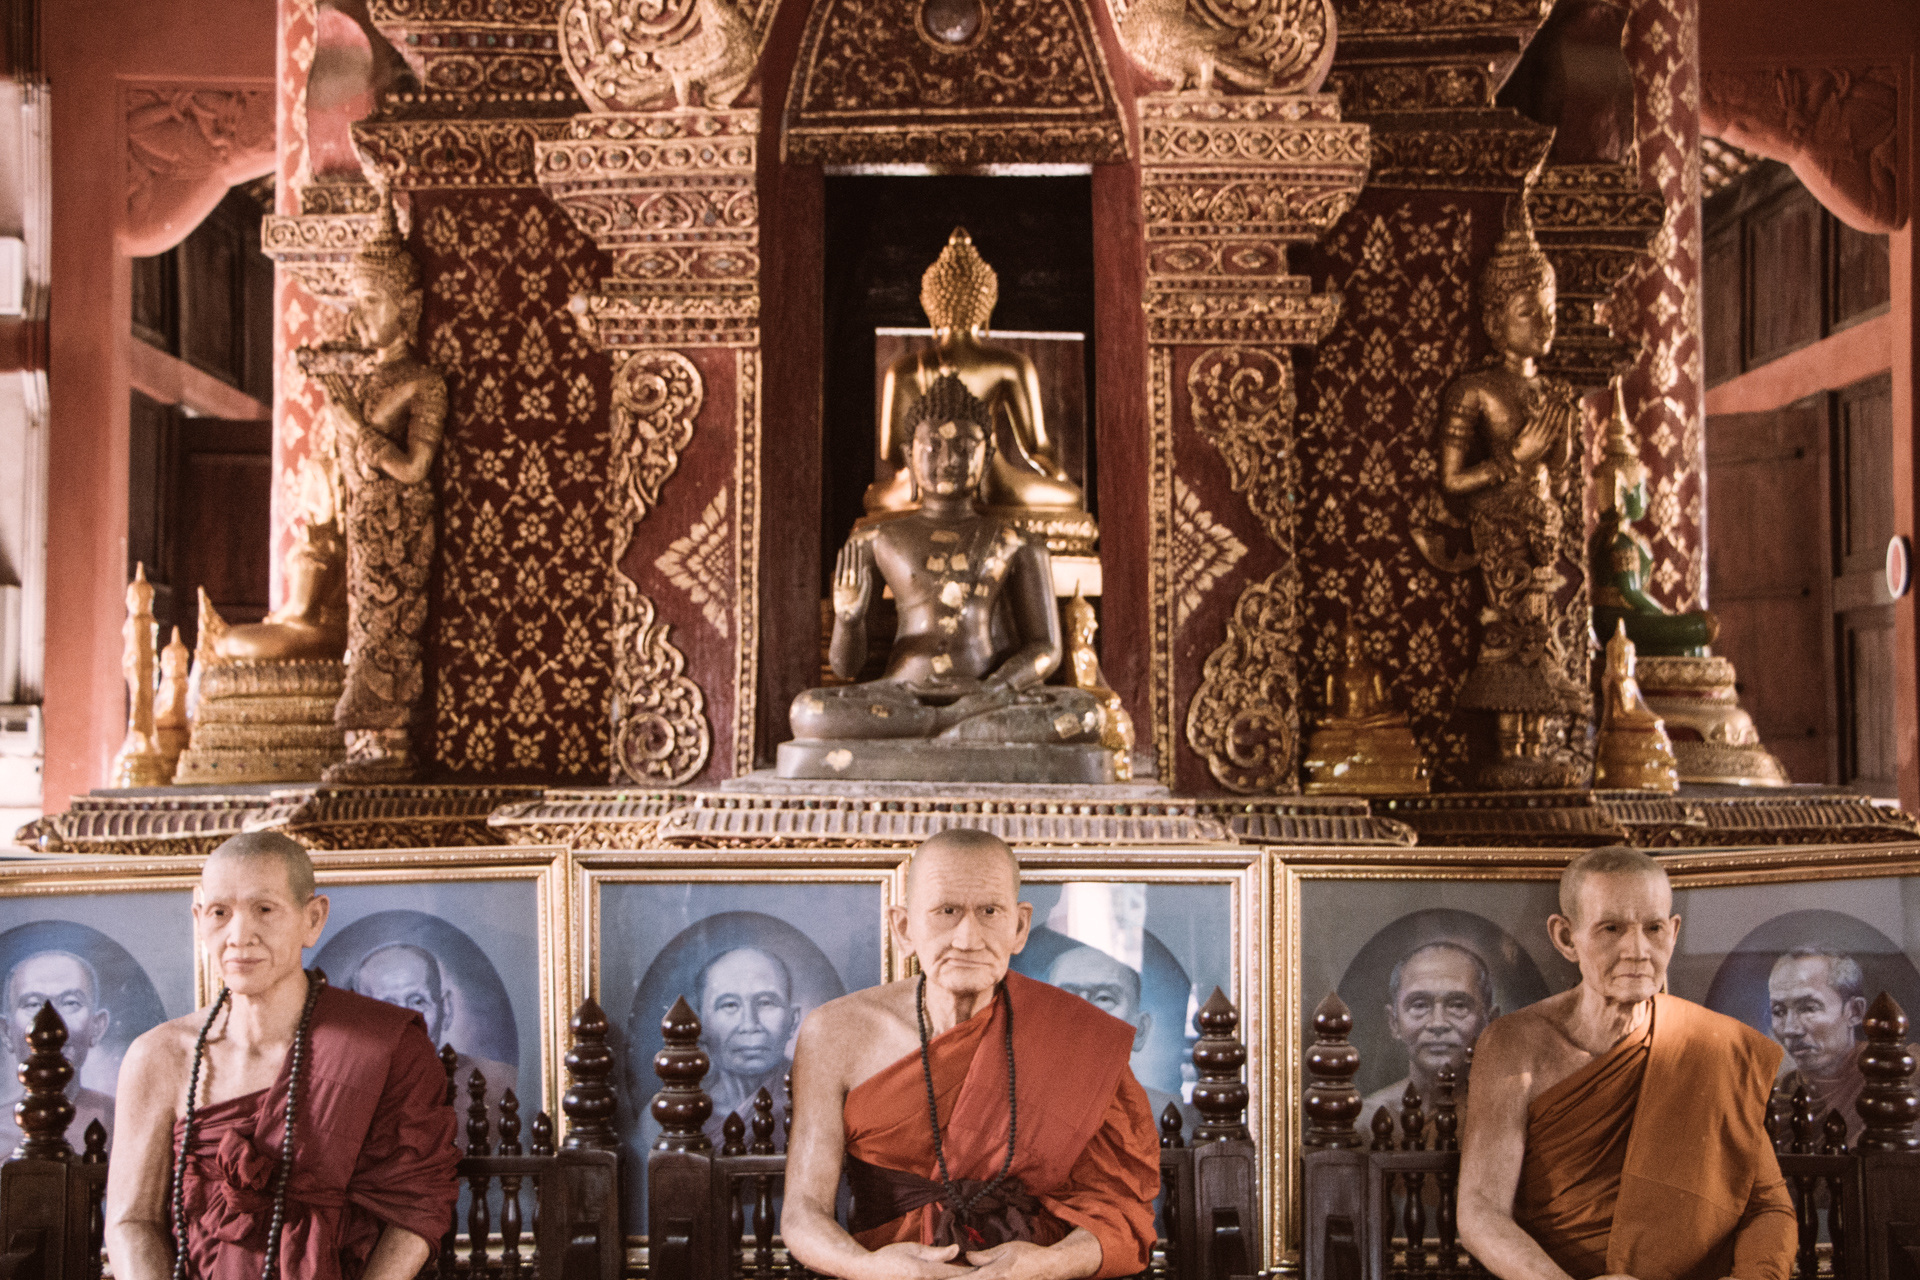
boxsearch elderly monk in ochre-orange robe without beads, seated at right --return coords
[1459,846,1795,1280]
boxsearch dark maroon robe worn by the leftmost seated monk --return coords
[169,986,459,1280]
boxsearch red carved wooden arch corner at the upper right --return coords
[1699,65,1907,232]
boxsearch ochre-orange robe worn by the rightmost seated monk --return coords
[1513,996,1795,1280]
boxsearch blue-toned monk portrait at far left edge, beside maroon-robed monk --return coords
[0,889,196,1151]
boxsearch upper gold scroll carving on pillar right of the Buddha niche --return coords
[1187,347,1298,549]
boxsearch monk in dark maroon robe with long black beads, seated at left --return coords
[106,831,459,1280]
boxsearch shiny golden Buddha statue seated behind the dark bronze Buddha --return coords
[866,226,1098,555]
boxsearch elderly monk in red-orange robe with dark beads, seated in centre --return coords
[780,831,1160,1280]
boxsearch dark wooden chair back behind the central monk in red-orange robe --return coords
[647,990,1263,1280]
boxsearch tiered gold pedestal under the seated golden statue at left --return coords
[173,662,348,785]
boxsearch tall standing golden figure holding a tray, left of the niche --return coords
[300,179,447,783]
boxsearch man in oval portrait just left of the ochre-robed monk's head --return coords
[1359,942,1500,1125]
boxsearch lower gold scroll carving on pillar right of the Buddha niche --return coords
[1187,562,1302,794]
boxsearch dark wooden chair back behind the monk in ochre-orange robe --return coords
[1300,992,1920,1280]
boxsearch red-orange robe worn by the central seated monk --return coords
[845,973,1160,1280]
